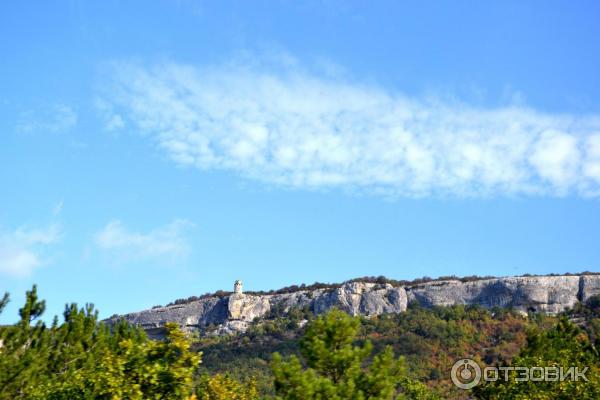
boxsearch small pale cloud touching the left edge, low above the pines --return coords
[0,225,61,277]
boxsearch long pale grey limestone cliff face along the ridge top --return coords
[108,275,600,336]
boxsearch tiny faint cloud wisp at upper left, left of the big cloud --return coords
[16,104,78,133]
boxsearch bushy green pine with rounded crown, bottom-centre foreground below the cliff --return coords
[272,310,436,400]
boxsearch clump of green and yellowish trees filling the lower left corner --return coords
[0,286,200,400]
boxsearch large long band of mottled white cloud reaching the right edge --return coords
[103,60,600,196]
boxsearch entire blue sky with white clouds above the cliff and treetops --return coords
[0,1,600,322]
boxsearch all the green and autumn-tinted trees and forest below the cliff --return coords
[0,287,600,400]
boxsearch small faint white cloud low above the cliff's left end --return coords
[94,219,193,262]
